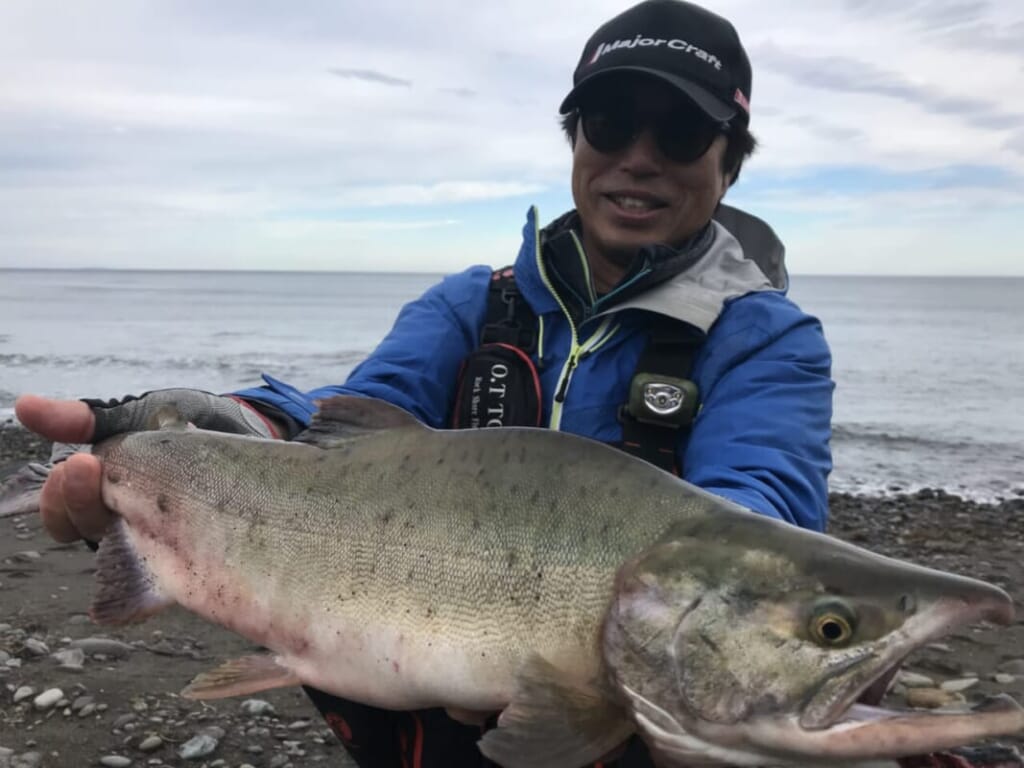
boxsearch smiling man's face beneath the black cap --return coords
[572,75,729,267]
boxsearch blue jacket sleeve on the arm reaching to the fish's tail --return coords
[234,266,492,427]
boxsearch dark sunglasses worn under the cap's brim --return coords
[578,96,729,163]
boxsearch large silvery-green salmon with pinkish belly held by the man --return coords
[8,397,1024,768]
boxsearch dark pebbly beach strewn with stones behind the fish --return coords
[0,425,1024,768]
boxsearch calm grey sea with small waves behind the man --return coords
[0,270,1024,499]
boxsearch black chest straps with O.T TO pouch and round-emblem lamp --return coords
[451,266,699,475]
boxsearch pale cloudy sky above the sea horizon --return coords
[0,0,1024,275]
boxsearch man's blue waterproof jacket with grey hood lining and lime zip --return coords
[236,206,833,530]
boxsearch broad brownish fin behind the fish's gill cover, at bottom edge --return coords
[479,656,634,768]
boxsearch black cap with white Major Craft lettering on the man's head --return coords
[559,0,751,123]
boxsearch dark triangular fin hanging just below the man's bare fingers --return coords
[89,519,174,625]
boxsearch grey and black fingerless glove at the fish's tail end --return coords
[83,389,288,442]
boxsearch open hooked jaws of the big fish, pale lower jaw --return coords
[624,595,1024,766]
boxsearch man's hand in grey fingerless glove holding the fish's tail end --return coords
[14,389,291,542]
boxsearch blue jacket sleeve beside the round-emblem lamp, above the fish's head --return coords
[683,294,834,530]
